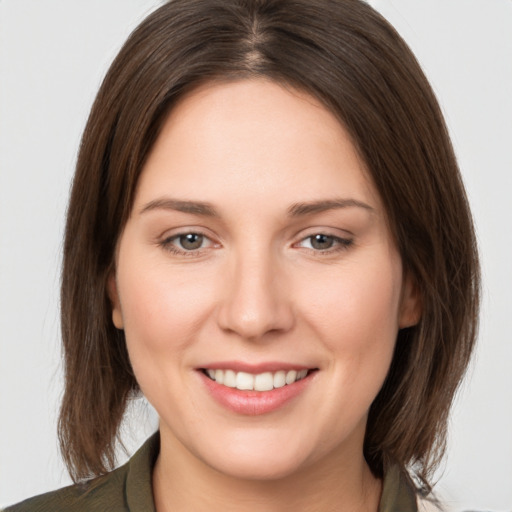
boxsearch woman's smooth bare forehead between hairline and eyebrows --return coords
[136,79,379,215]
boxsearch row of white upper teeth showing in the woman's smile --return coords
[206,368,308,391]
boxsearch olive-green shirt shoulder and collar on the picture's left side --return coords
[3,432,160,512]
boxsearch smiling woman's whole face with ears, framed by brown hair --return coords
[109,79,417,479]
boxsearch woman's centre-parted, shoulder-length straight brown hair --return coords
[59,0,479,487]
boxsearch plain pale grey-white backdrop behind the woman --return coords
[0,0,512,511]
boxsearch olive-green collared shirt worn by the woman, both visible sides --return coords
[4,432,417,512]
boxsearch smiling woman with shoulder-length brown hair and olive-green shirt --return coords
[5,0,479,511]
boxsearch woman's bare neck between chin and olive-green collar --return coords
[153,430,382,512]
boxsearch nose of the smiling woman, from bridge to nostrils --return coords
[218,249,294,341]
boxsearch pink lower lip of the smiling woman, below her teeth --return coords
[199,371,316,416]
